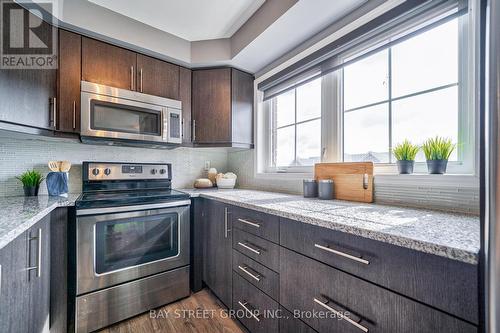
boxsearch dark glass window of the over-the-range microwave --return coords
[90,100,161,136]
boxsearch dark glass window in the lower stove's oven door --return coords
[95,213,179,274]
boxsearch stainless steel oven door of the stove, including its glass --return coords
[76,202,189,295]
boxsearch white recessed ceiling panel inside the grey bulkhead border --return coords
[89,0,265,41]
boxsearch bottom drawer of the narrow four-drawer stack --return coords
[233,273,279,333]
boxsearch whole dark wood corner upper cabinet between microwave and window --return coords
[192,68,253,147]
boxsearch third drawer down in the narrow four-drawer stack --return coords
[233,250,279,300]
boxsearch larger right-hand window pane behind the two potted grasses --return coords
[342,19,460,163]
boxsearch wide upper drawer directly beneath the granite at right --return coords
[280,219,478,323]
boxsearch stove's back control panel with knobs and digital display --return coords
[83,162,172,180]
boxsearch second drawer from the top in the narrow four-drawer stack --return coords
[233,229,280,272]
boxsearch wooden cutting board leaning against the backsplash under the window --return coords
[314,162,373,202]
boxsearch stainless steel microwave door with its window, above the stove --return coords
[81,92,168,143]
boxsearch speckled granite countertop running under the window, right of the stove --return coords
[182,189,480,264]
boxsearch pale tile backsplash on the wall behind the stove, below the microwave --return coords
[0,134,227,196]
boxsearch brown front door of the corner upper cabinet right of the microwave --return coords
[192,68,231,144]
